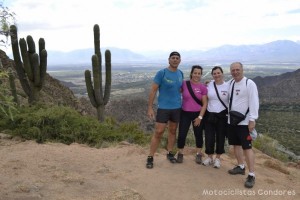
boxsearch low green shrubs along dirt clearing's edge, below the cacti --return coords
[1,105,147,146]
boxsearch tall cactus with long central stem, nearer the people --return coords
[85,24,111,122]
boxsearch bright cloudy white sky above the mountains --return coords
[4,0,300,52]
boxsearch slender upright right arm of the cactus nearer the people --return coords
[103,50,111,105]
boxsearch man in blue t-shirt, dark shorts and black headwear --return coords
[146,51,183,169]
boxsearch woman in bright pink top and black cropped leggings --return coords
[177,65,207,164]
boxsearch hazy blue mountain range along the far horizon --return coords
[48,40,300,66]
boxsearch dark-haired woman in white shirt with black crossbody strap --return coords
[202,66,229,168]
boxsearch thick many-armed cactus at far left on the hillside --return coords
[10,25,47,104]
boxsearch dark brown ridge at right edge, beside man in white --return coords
[253,68,300,105]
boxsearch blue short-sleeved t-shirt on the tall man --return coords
[153,68,183,109]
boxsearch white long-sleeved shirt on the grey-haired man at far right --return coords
[228,77,259,125]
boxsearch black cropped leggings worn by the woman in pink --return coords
[177,110,204,149]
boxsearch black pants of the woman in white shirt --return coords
[205,111,227,155]
